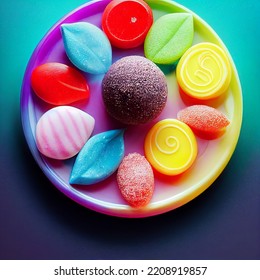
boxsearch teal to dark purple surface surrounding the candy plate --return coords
[0,0,260,259]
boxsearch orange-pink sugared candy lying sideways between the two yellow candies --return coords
[177,105,230,138]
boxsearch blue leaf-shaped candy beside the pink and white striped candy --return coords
[70,129,124,185]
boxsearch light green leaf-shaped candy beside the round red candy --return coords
[144,13,194,64]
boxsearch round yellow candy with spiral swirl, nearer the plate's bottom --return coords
[144,119,197,175]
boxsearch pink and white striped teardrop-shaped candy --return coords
[36,106,95,160]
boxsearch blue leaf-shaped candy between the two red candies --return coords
[61,22,112,74]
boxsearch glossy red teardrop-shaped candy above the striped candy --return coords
[31,62,89,105]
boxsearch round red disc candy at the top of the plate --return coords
[102,0,153,49]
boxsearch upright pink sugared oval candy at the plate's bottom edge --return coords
[117,153,154,208]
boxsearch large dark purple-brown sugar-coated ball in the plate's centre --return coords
[102,56,168,125]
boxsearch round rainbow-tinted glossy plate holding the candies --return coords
[21,0,242,218]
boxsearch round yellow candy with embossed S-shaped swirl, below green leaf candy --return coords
[176,43,231,100]
